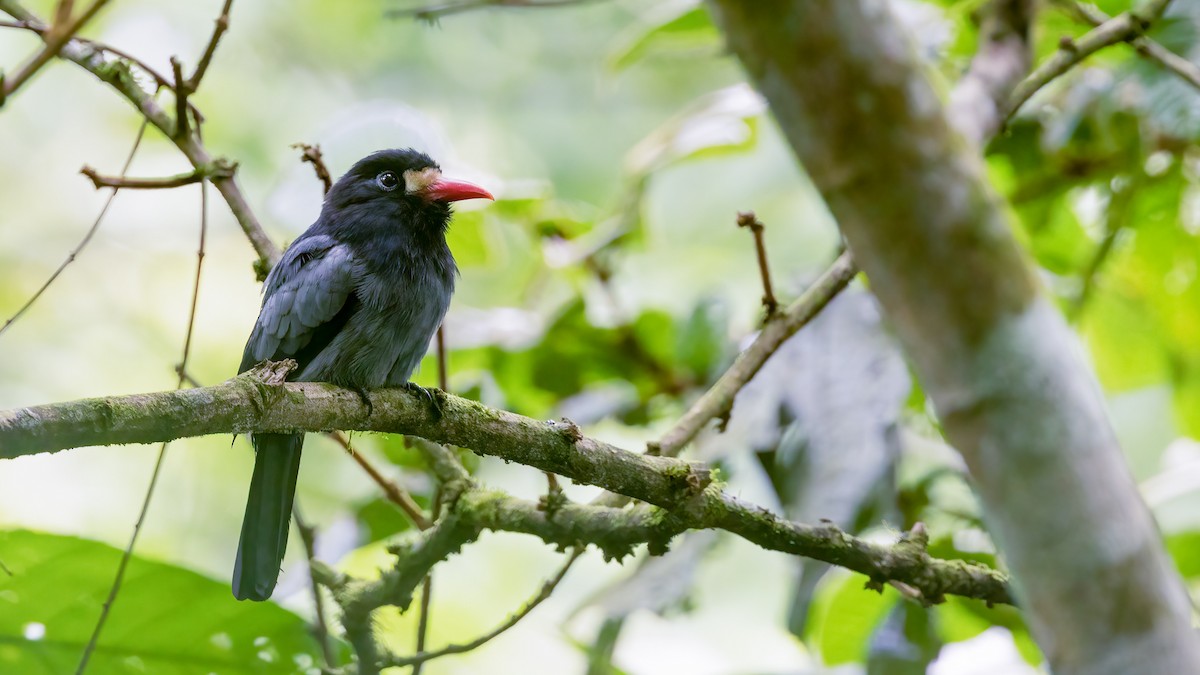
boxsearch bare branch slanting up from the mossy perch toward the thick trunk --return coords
[647,253,858,456]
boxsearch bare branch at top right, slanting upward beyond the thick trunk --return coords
[1006,0,1170,118]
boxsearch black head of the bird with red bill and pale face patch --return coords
[325,149,494,237]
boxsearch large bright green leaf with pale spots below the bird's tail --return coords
[0,530,331,675]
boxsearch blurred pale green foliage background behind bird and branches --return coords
[7,0,1200,675]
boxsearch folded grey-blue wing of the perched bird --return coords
[239,235,358,372]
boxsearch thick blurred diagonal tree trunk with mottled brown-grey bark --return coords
[710,0,1200,675]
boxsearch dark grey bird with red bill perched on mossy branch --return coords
[233,148,494,602]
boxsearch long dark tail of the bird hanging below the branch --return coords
[233,434,304,601]
